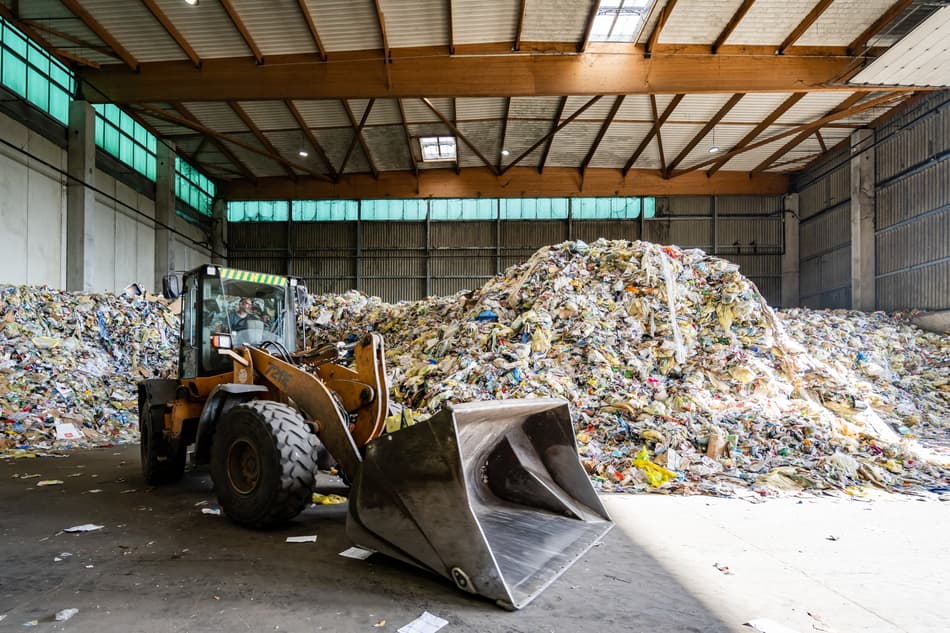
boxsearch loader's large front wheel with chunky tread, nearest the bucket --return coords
[211,400,320,528]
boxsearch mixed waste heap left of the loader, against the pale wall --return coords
[0,285,178,457]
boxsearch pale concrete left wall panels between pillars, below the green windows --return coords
[0,109,211,292]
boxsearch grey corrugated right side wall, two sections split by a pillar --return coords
[795,91,950,311]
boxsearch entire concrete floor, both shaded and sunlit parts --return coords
[0,446,950,633]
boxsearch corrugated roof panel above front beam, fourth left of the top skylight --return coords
[307,0,383,52]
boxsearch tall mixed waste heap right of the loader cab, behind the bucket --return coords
[308,240,950,495]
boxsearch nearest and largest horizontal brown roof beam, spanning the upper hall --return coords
[81,52,919,104]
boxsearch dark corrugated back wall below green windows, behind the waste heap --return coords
[228,196,784,305]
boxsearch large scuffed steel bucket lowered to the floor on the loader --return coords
[347,399,613,609]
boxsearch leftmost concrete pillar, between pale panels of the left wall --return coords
[66,101,96,292]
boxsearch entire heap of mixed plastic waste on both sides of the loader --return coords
[0,240,950,495]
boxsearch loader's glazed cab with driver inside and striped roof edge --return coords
[163,265,306,379]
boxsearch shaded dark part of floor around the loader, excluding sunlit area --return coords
[0,447,736,633]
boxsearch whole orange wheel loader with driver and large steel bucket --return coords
[138,265,613,609]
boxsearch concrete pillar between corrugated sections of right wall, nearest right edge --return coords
[851,130,877,312]
